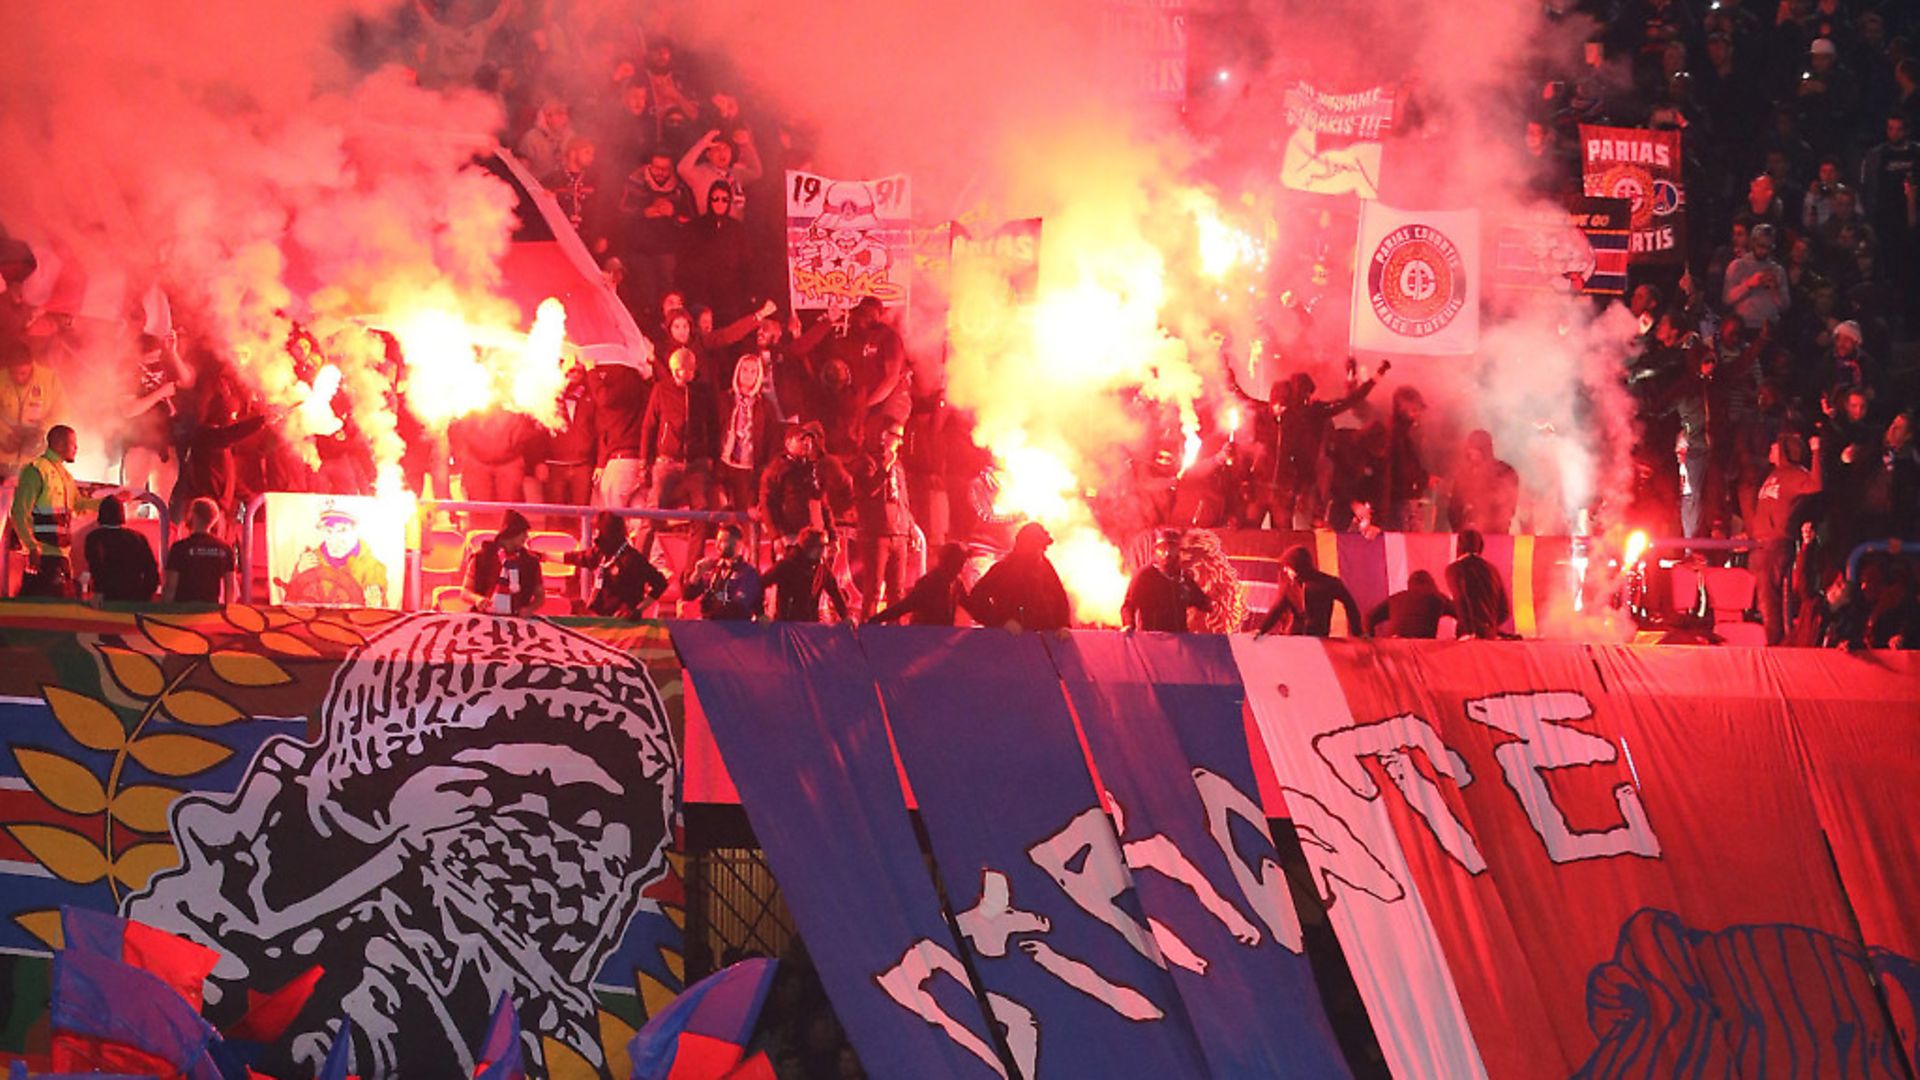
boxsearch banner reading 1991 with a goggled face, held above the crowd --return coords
[787,169,914,313]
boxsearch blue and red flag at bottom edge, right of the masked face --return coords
[630,957,778,1080]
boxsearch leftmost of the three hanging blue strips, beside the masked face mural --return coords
[674,623,1006,1080]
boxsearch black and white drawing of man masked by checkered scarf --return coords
[127,613,678,1078]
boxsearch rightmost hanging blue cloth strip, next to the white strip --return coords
[1050,634,1348,1080]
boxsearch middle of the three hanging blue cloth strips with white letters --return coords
[862,626,1208,1080]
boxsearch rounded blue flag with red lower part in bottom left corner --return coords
[50,949,221,1080]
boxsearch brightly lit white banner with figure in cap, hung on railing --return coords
[267,492,407,609]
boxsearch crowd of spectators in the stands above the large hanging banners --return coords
[0,0,1920,648]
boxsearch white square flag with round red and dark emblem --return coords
[1352,202,1480,356]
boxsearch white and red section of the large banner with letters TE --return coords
[1238,642,1903,1080]
